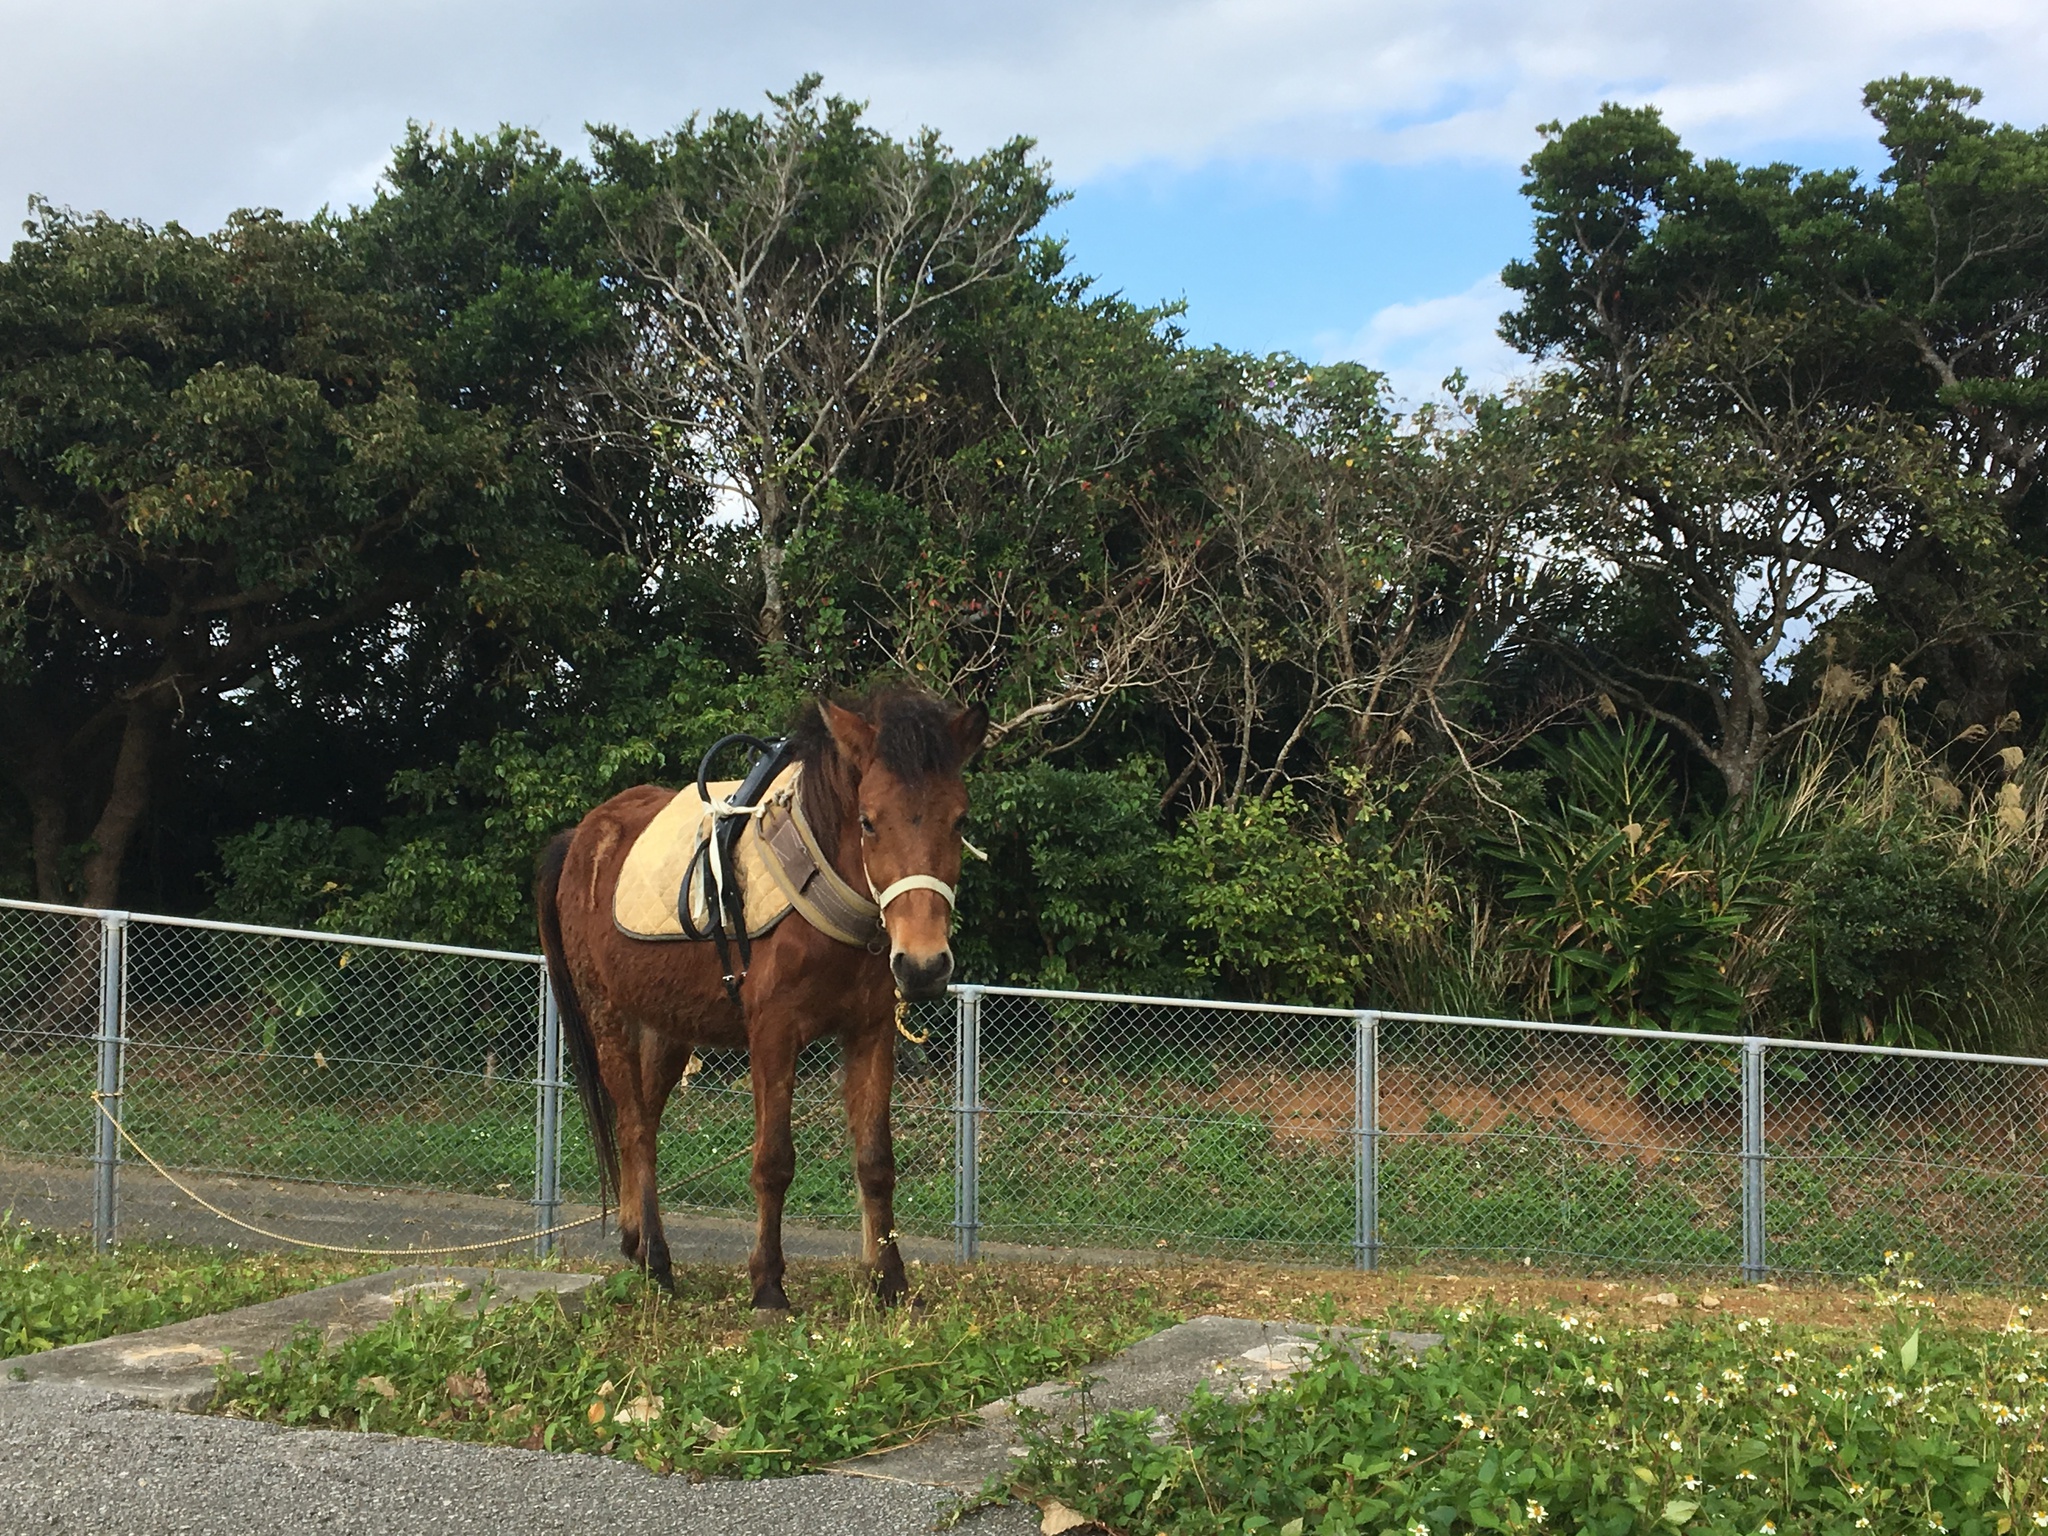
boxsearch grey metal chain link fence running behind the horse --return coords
[0,903,2048,1282]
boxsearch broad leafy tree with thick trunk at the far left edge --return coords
[0,207,593,905]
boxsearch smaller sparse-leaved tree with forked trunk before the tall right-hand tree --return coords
[1532,305,1972,803]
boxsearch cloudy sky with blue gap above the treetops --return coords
[0,0,2048,399]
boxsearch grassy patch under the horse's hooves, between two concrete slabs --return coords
[217,1266,1178,1477]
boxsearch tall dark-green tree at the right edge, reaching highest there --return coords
[1503,76,2048,758]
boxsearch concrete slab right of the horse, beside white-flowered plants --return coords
[825,1317,1444,1493]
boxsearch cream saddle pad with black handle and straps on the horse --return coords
[612,737,883,999]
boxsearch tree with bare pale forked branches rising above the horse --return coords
[590,76,1051,647]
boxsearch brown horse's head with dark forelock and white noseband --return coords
[821,692,989,997]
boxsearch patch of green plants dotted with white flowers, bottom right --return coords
[1010,1290,2048,1536]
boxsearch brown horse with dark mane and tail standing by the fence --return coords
[537,690,989,1309]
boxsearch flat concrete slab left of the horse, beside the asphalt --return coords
[8,1264,604,1411]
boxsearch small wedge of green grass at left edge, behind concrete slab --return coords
[0,1214,375,1356]
